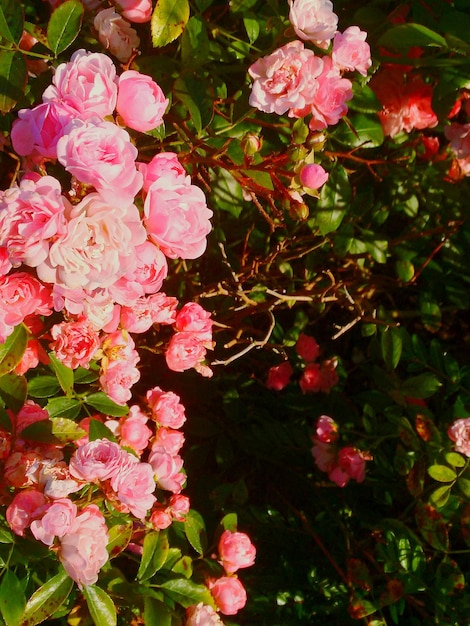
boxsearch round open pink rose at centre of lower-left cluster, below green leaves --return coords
[69,439,125,483]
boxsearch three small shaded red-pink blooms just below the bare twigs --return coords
[266,333,339,393]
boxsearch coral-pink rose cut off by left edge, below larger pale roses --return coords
[0,272,52,343]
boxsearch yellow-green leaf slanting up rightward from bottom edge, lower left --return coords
[18,567,74,626]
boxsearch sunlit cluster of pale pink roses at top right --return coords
[248,0,371,131]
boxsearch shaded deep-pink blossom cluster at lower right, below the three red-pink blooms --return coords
[312,415,373,487]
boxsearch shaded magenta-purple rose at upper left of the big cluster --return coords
[10,101,77,159]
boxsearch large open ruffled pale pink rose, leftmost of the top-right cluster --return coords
[248,40,323,115]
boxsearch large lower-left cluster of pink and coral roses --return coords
[0,387,189,586]
